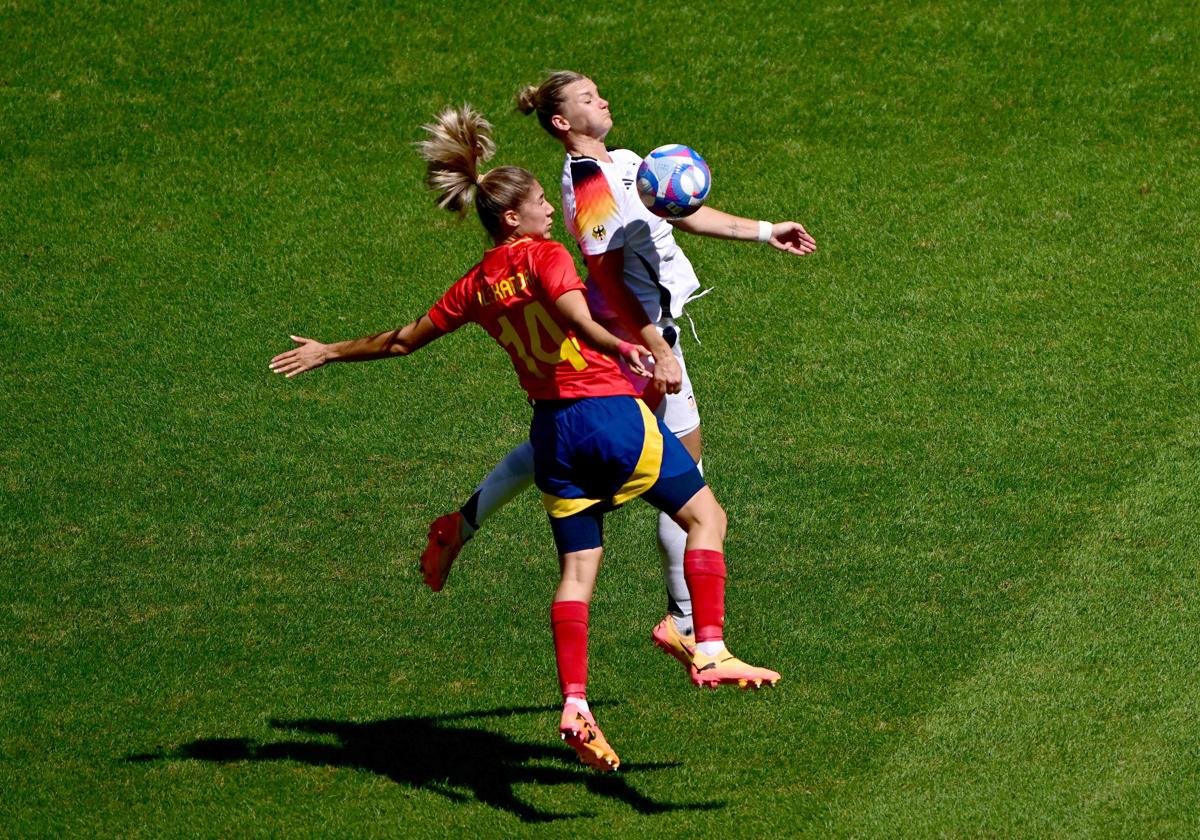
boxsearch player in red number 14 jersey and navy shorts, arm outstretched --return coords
[270,106,779,770]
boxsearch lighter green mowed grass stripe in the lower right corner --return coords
[824,415,1200,836]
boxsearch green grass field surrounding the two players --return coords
[0,0,1200,838]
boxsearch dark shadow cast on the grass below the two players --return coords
[127,707,725,822]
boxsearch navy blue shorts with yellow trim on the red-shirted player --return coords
[529,396,704,554]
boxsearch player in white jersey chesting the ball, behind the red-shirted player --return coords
[421,71,816,670]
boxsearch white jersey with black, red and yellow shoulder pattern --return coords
[563,149,700,323]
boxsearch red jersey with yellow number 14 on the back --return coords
[430,236,636,400]
